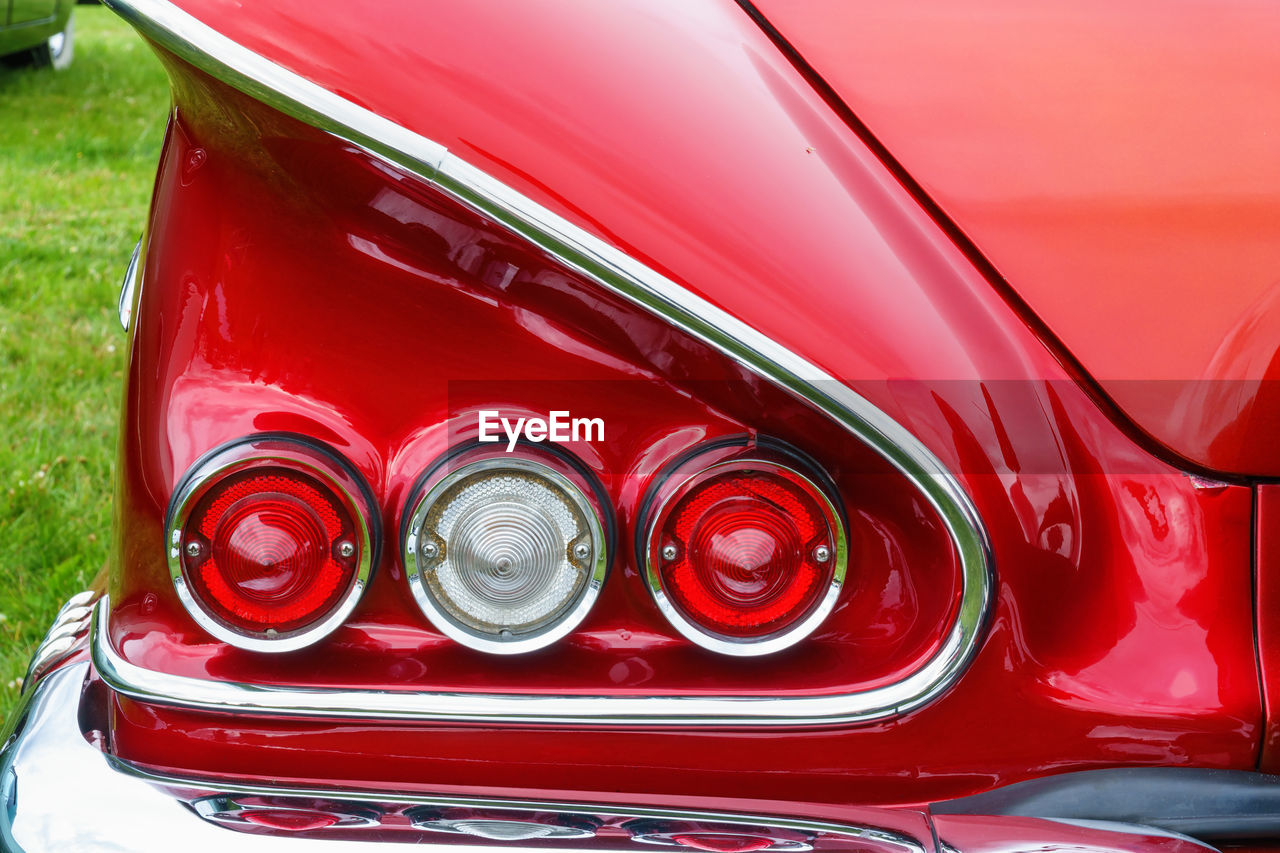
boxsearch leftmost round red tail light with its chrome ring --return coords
[169,438,372,652]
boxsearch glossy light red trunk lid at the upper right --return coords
[755,0,1280,475]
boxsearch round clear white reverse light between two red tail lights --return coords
[404,459,608,654]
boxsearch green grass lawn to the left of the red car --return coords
[0,6,169,717]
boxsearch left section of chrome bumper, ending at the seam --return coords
[0,661,934,853]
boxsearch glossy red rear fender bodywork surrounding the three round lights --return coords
[99,1,1262,803]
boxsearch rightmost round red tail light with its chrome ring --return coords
[645,459,847,656]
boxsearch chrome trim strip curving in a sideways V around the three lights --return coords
[102,0,995,725]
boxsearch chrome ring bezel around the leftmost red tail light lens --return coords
[165,433,380,653]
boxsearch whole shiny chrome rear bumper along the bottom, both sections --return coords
[0,661,1213,853]
